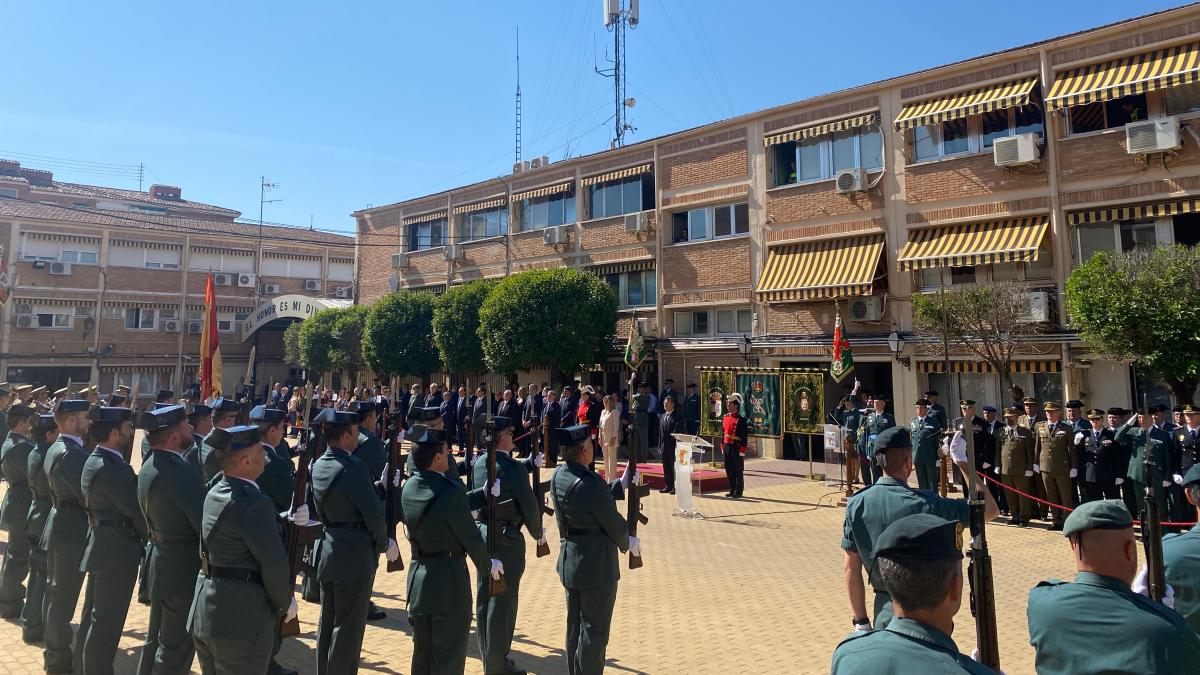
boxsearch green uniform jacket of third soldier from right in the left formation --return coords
[401,468,490,616]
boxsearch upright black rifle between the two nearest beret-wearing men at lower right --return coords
[960,417,1000,673]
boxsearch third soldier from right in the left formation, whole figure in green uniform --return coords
[401,426,504,675]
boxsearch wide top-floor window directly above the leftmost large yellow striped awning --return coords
[774,127,883,186]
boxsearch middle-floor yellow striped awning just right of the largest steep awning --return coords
[896,216,1050,271]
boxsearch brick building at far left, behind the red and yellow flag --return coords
[0,160,354,400]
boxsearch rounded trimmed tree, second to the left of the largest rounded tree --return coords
[362,291,439,378]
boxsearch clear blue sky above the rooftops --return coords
[0,0,1180,231]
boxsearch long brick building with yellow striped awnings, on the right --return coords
[354,6,1200,456]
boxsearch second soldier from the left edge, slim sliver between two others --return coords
[20,414,59,645]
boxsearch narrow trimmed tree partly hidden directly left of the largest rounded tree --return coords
[433,279,496,375]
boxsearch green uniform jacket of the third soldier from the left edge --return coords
[42,435,88,560]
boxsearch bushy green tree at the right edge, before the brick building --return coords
[1066,246,1200,401]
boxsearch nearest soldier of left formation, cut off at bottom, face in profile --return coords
[187,425,306,675]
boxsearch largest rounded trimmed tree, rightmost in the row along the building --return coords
[479,268,617,372]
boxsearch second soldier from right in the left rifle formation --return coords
[474,417,545,675]
